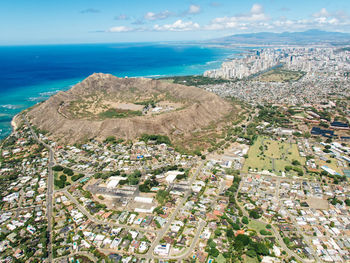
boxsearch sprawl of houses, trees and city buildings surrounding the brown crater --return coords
[0,45,350,263]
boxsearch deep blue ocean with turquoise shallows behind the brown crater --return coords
[0,43,240,139]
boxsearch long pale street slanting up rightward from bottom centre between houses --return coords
[144,162,204,259]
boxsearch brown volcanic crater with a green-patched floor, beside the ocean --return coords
[28,73,233,143]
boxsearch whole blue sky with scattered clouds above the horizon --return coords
[0,0,350,45]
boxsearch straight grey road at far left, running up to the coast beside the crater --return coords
[22,114,54,263]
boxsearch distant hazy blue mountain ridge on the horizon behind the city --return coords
[212,29,350,45]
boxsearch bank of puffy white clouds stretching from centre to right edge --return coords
[103,4,350,33]
